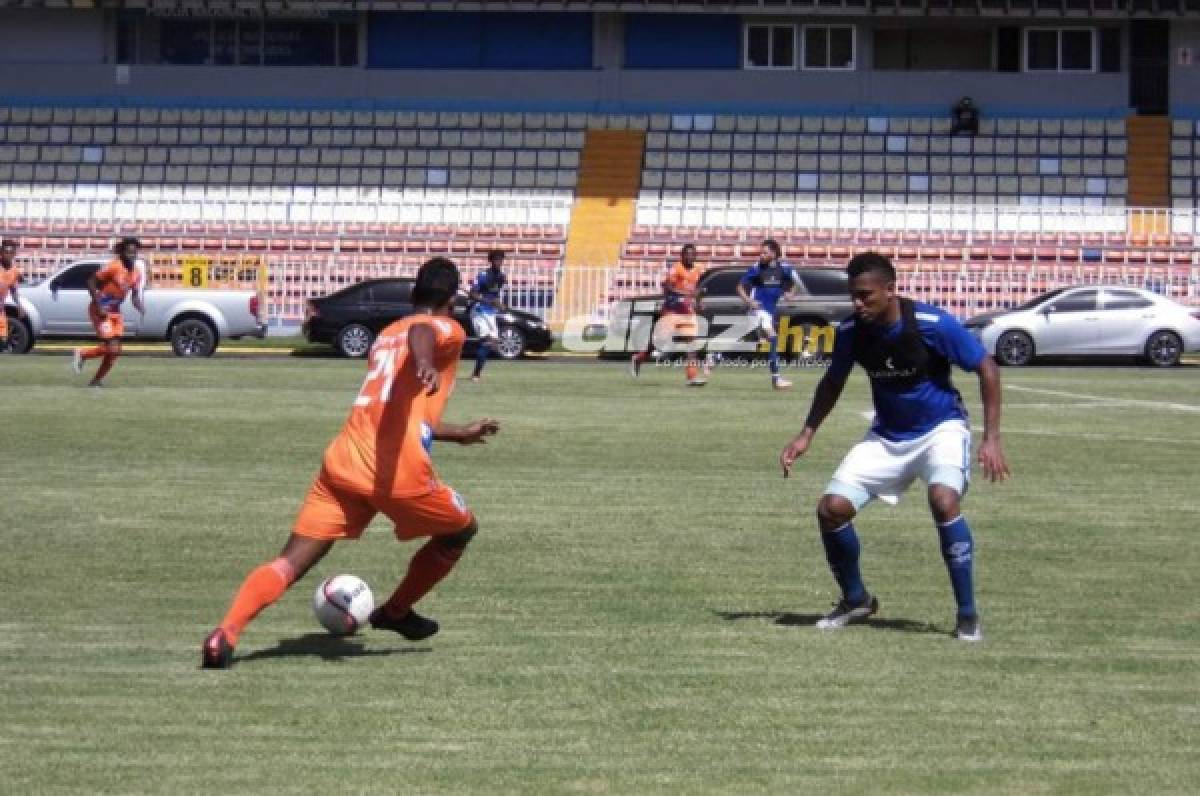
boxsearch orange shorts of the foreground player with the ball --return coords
[292,467,473,540]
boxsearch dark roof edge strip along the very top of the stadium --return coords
[7,0,1200,19]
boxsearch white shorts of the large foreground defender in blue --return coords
[826,419,971,510]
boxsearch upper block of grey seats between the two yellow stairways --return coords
[640,114,1128,214]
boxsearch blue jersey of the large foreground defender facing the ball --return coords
[829,301,986,442]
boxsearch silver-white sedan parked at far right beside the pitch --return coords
[966,285,1200,367]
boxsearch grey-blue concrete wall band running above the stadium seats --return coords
[0,11,1128,115]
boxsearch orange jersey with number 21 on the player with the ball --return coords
[324,315,467,497]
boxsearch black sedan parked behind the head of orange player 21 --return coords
[304,279,554,359]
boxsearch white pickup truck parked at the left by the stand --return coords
[4,259,266,357]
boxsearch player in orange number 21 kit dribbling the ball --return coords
[202,257,499,669]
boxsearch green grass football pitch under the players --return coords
[0,355,1200,795]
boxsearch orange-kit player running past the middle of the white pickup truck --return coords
[71,238,146,387]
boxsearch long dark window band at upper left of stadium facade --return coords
[158,19,359,66]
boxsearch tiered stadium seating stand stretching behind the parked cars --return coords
[0,107,1200,324]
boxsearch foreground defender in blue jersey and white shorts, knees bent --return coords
[780,252,1009,641]
